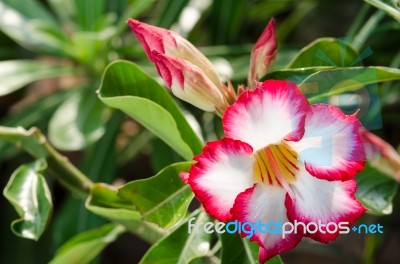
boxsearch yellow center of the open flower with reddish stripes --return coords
[253,140,299,189]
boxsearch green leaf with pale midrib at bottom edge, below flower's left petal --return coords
[140,210,211,264]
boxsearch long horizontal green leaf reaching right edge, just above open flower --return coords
[299,67,400,103]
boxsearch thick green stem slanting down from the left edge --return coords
[0,126,93,198]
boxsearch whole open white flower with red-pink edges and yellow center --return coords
[180,80,366,263]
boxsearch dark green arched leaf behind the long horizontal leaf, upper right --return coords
[288,38,362,69]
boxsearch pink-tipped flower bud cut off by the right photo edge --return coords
[360,128,400,182]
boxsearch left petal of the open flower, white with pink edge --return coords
[187,138,253,221]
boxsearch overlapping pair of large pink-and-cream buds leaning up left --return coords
[127,19,236,113]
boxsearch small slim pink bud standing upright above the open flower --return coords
[247,18,278,89]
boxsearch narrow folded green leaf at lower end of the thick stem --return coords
[86,183,164,243]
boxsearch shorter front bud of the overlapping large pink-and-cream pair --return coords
[152,51,228,112]
